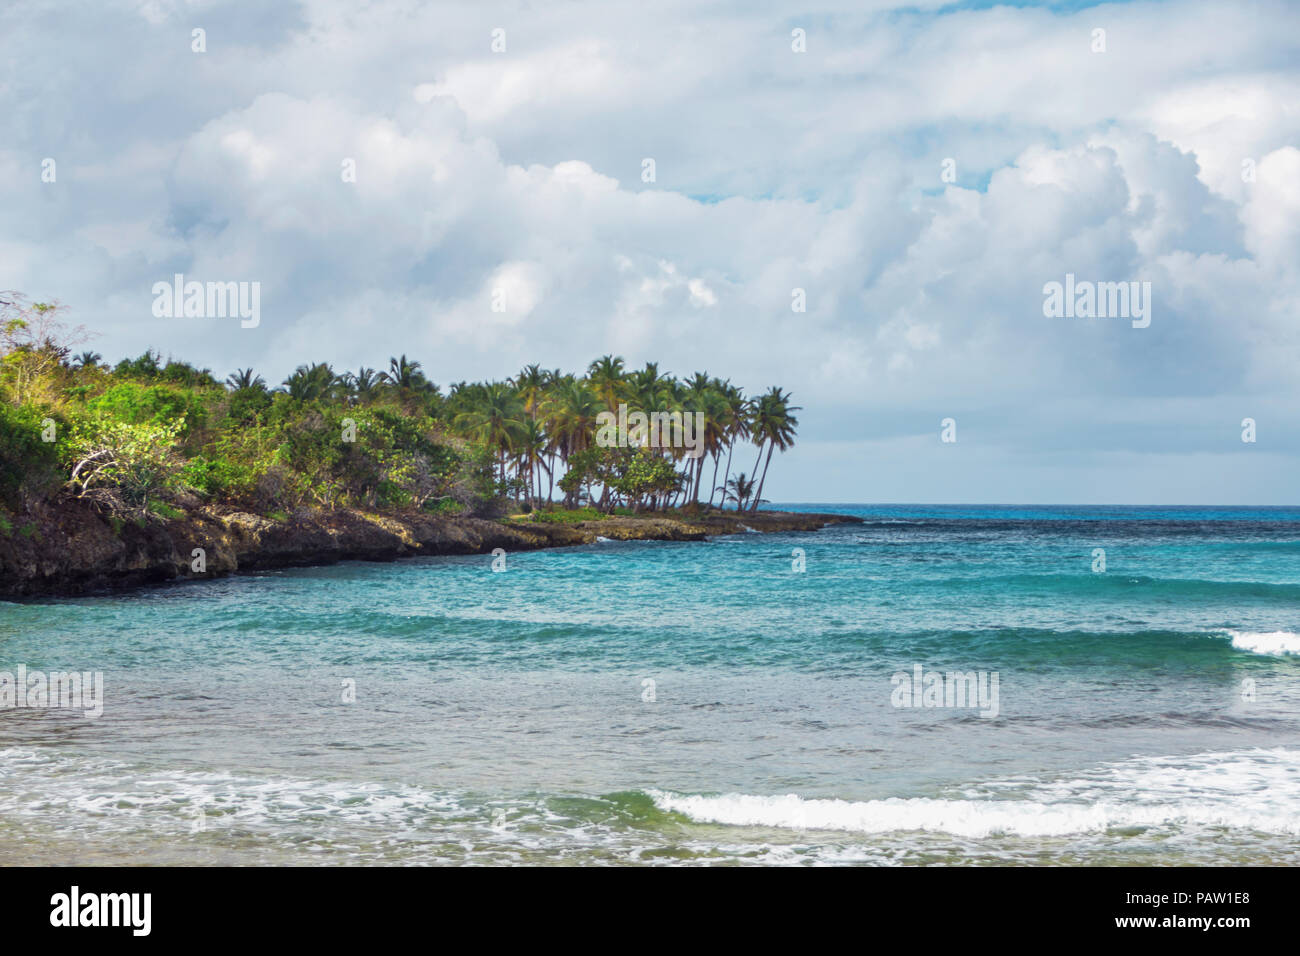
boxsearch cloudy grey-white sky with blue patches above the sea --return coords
[0,0,1300,505]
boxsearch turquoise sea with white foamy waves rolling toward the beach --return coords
[0,505,1300,864]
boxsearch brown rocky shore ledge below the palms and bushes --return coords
[0,501,859,600]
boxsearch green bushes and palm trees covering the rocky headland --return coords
[0,293,798,533]
